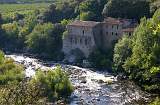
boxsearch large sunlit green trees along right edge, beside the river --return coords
[114,10,160,92]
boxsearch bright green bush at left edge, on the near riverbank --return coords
[0,52,24,85]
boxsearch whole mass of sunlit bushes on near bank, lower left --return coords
[0,52,73,105]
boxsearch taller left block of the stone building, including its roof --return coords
[63,21,102,57]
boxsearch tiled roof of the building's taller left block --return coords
[69,20,100,27]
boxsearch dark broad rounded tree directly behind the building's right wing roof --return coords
[103,0,150,20]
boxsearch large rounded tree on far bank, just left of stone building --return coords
[26,23,64,57]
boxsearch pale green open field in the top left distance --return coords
[0,3,49,15]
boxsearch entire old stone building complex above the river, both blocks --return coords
[63,17,136,57]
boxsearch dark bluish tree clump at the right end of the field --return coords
[40,0,79,23]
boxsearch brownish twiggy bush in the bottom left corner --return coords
[0,81,47,105]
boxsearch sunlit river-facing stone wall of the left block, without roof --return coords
[63,26,96,57]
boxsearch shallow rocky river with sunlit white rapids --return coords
[6,54,150,105]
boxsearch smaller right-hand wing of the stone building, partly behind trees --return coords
[102,17,137,50]
